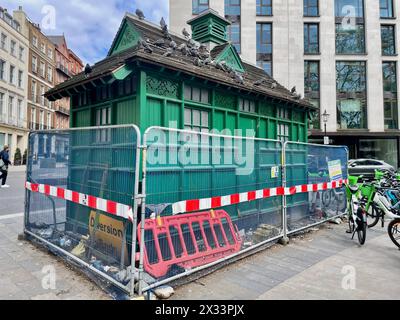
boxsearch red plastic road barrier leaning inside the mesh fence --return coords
[138,210,242,278]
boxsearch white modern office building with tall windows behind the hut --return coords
[170,0,400,167]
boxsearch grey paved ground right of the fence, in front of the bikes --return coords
[173,224,400,300]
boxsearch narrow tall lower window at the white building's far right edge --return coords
[382,62,399,129]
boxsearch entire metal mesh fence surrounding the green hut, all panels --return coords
[25,126,348,295]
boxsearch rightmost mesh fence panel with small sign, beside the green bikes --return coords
[284,142,348,234]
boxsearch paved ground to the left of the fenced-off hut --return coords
[0,167,110,300]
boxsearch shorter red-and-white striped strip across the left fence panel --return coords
[25,182,133,221]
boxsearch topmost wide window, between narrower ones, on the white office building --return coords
[335,0,365,54]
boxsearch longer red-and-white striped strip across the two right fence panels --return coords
[172,180,347,214]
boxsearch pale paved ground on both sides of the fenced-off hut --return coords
[0,168,400,300]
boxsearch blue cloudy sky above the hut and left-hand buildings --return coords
[0,0,168,64]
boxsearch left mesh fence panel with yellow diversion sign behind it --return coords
[25,126,141,293]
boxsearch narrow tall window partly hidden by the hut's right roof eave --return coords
[304,61,321,129]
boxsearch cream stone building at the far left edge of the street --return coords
[0,7,29,161]
